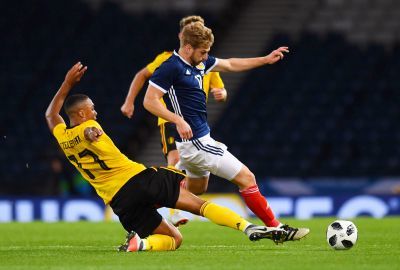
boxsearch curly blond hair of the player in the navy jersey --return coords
[180,22,214,49]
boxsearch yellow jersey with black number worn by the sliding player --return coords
[53,120,146,204]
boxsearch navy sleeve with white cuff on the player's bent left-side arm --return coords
[149,61,176,93]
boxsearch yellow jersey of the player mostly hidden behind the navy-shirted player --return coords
[146,51,224,125]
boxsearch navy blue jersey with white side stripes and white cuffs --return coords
[149,51,217,142]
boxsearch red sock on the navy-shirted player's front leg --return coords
[240,185,279,227]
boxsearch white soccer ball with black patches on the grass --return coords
[326,220,358,249]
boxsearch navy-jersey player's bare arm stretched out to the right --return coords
[212,47,289,72]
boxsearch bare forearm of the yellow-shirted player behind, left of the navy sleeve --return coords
[121,67,152,118]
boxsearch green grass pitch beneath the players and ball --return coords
[0,218,400,270]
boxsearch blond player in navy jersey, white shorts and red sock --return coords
[144,22,309,240]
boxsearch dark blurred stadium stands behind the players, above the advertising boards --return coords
[0,0,400,196]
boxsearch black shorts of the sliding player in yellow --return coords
[110,168,185,238]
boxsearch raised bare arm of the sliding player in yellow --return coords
[46,62,87,132]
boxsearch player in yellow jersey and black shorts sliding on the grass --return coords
[46,62,287,252]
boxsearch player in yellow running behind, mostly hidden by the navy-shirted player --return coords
[121,16,227,226]
